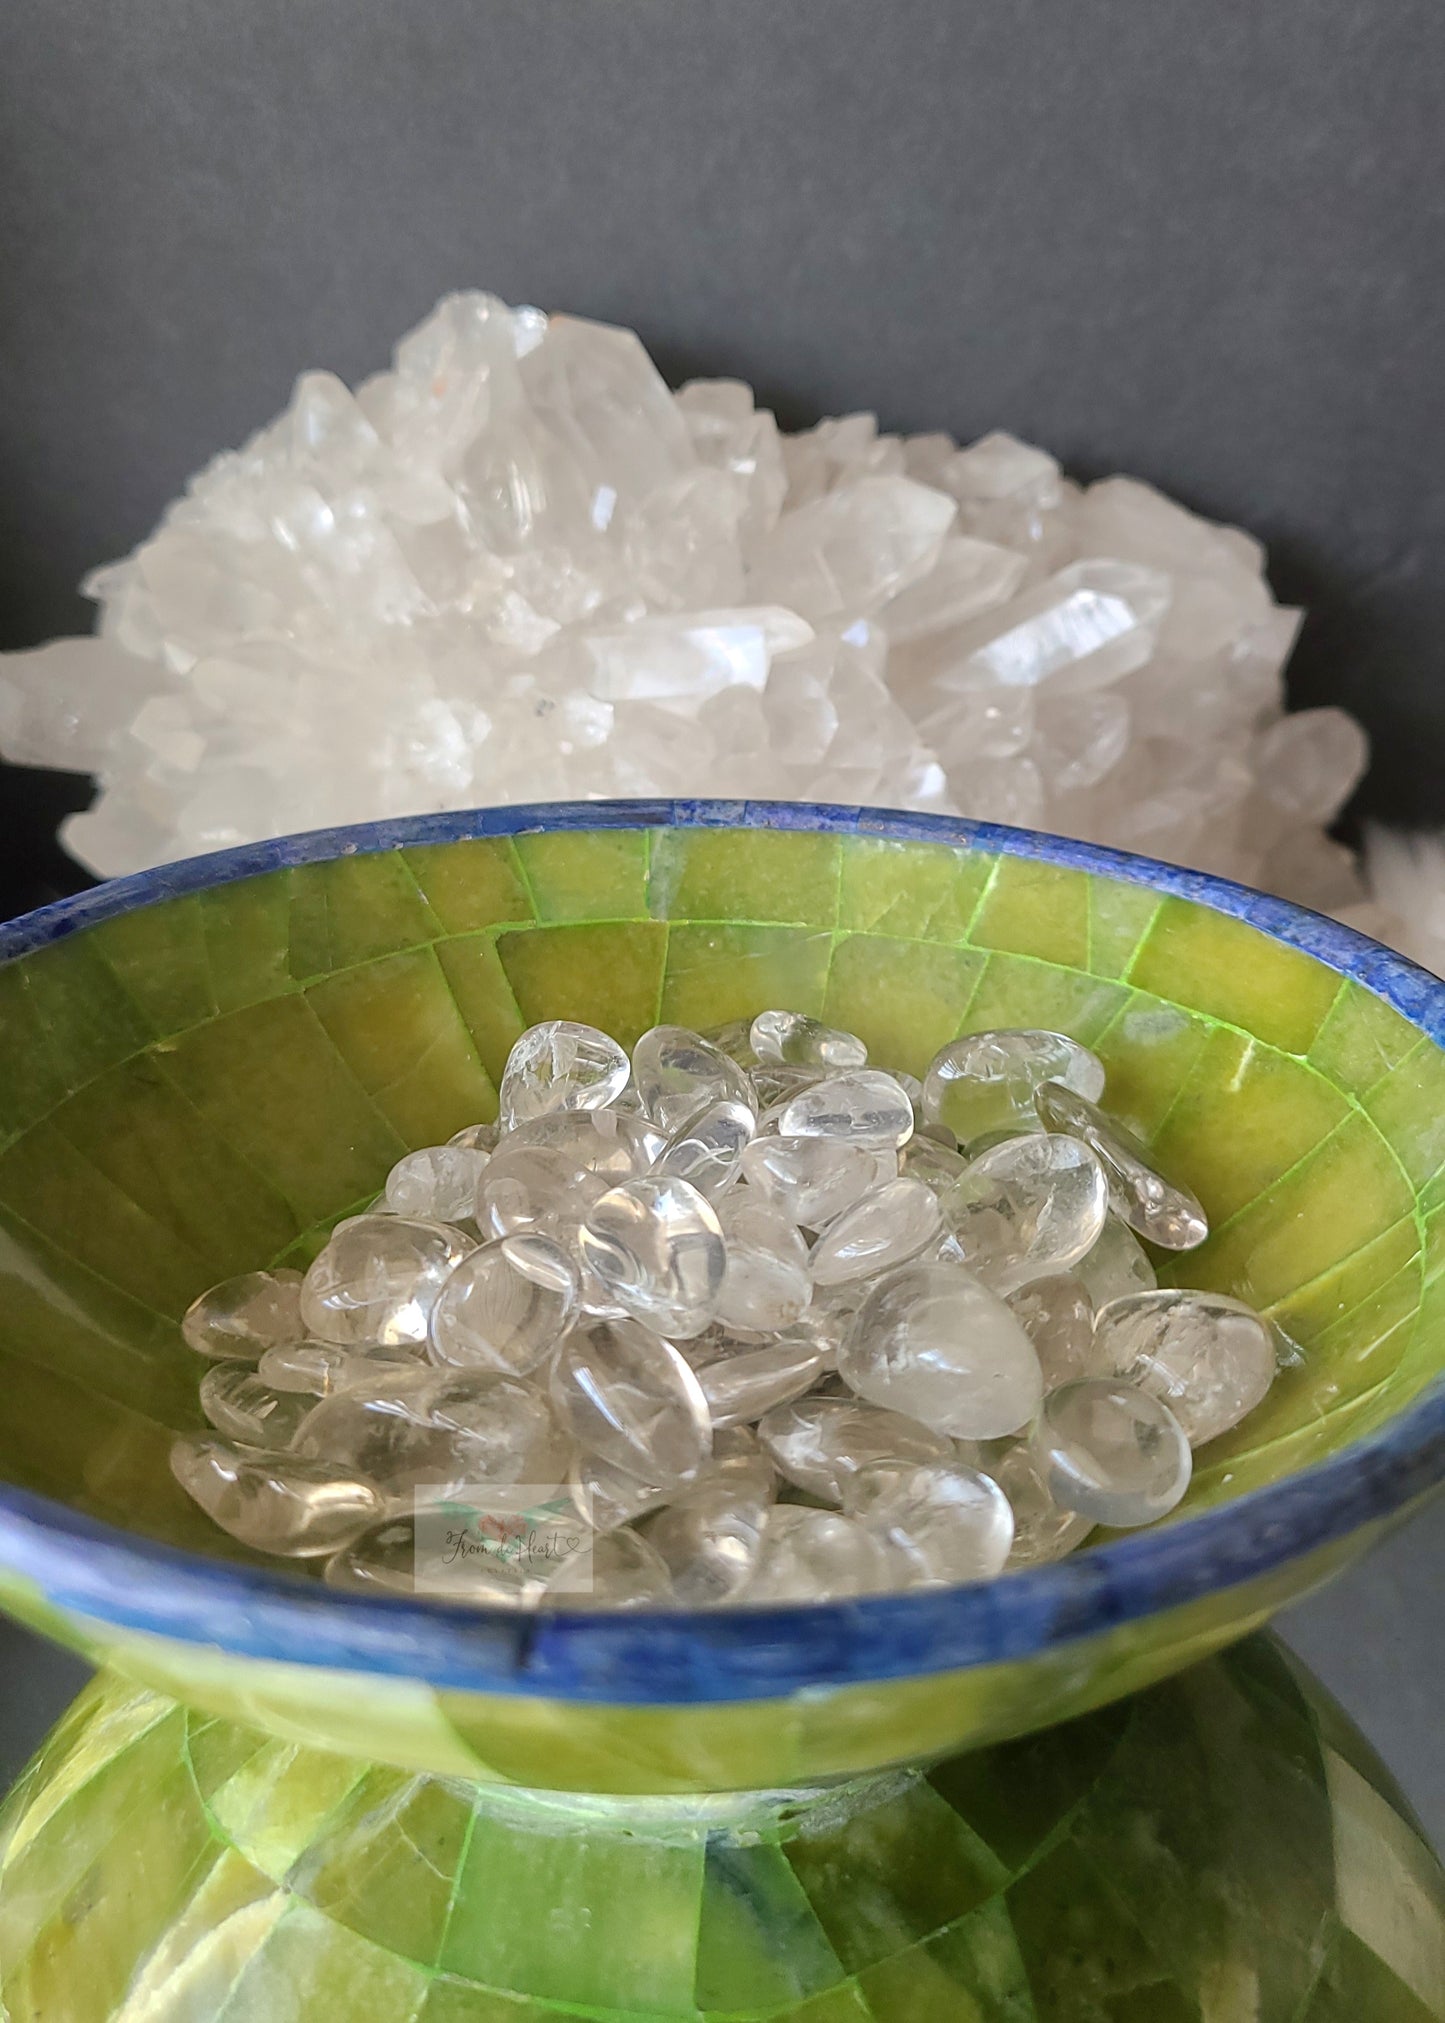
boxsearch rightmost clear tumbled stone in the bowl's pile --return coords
[1095,1289,1275,1446]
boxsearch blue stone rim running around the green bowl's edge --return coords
[0,799,1445,1705]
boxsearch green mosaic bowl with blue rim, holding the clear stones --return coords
[0,803,1445,1794]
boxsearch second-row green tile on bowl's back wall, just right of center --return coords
[824,935,986,1074]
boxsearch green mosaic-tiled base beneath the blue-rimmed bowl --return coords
[0,1639,1445,2023]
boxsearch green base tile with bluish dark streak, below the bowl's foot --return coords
[692,1835,844,2015]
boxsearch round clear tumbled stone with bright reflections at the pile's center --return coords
[581,1177,727,1335]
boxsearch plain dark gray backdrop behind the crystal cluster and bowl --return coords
[0,0,1445,1835]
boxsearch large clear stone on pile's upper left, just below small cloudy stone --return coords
[302,1216,476,1347]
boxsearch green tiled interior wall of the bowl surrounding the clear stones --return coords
[0,809,1445,1558]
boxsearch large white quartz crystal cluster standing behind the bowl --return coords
[0,293,1366,926]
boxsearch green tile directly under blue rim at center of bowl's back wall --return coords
[648,829,842,927]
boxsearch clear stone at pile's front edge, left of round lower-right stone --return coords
[844,1463,1014,1588]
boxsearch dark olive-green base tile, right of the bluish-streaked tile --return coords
[785,1782,1008,1974]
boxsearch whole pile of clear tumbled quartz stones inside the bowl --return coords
[172,1012,1277,1606]
